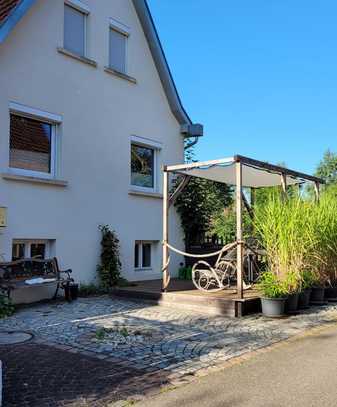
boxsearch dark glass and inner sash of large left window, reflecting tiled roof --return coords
[9,113,55,174]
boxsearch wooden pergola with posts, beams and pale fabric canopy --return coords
[162,155,324,299]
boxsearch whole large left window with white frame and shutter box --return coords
[9,104,61,177]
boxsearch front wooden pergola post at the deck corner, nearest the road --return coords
[235,161,244,299]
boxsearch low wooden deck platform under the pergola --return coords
[114,279,261,317]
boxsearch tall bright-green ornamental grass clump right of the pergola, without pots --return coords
[254,191,318,293]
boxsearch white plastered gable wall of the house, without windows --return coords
[0,0,183,281]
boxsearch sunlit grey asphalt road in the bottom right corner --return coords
[137,326,337,407]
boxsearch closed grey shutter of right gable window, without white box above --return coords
[109,27,128,74]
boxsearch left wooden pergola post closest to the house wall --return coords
[162,166,170,291]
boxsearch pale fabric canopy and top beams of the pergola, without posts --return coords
[166,155,324,188]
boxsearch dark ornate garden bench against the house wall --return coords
[0,257,74,298]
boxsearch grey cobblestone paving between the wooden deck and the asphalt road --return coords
[0,297,337,405]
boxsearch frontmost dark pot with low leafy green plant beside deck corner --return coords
[257,271,287,318]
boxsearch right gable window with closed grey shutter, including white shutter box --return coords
[109,19,130,74]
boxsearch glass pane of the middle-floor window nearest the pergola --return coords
[131,143,155,189]
